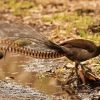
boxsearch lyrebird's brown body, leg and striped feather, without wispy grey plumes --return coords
[0,39,100,83]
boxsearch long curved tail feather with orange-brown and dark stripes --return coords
[0,46,64,59]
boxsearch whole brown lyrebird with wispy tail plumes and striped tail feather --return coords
[0,21,100,85]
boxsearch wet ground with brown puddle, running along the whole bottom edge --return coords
[0,54,100,100]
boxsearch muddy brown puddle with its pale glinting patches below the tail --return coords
[0,54,68,100]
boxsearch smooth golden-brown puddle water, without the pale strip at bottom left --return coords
[0,54,65,98]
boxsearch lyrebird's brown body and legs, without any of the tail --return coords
[59,39,100,84]
